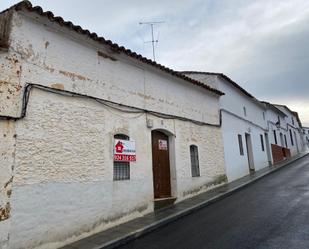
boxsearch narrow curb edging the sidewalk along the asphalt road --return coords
[93,152,309,249]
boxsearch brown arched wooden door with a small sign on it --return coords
[151,131,171,199]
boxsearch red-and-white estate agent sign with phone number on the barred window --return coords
[114,139,136,162]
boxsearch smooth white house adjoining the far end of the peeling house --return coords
[182,71,272,181]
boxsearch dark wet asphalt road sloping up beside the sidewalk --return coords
[119,156,309,249]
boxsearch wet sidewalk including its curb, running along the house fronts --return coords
[62,152,308,249]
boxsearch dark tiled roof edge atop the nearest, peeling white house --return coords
[1,1,224,96]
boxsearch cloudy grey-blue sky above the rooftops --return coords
[0,0,309,126]
